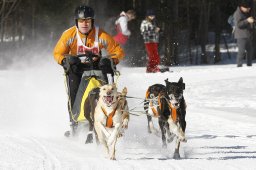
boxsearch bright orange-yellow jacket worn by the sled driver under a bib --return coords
[53,26,124,64]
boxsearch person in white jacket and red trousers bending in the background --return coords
[114,10,136,45]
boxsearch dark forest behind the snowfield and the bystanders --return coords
[0,0,256,68]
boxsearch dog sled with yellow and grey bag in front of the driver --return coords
[64,52,119,143]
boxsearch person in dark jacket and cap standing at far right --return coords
[234,0,255,67]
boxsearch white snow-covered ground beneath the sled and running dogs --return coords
[0,55,256,170]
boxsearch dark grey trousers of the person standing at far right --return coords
[237,38,253,66]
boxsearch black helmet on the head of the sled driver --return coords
[75,5,94,20]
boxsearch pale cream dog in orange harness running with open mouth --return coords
[94,84,129,160]
